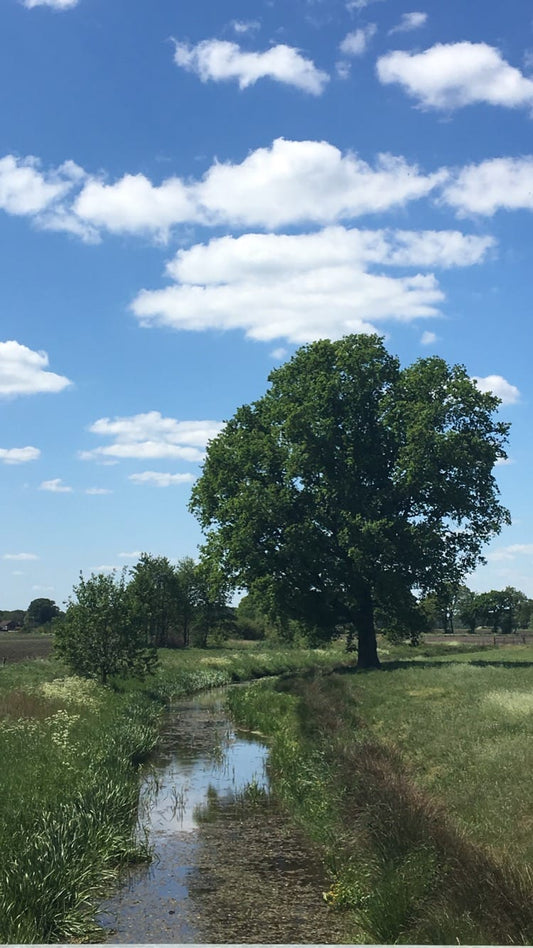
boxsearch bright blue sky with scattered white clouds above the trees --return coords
[0,0,533,609]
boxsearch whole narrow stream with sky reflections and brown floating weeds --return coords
[98,692,345,944]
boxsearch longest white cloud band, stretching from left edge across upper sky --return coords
[9,138,448,241]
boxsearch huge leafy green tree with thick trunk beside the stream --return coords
[190,335,509,667]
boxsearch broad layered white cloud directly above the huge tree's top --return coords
[132,227,493,343]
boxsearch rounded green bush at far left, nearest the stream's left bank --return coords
[54,571,157,685]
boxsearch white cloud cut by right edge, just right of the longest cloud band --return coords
[443,155,533,216]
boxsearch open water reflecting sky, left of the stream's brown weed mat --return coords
[98,692,268,943]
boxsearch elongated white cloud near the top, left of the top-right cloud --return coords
[174,39,329,95]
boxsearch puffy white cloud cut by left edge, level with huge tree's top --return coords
[0,339,72,396]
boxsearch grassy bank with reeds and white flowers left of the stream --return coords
[0,646,358,944]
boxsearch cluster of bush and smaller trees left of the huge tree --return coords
[53,553,231,684]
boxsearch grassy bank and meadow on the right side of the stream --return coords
[230,646,533,944]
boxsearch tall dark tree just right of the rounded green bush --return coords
[129,553,180,648]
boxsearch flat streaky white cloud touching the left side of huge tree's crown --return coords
[79,411,222,461]
